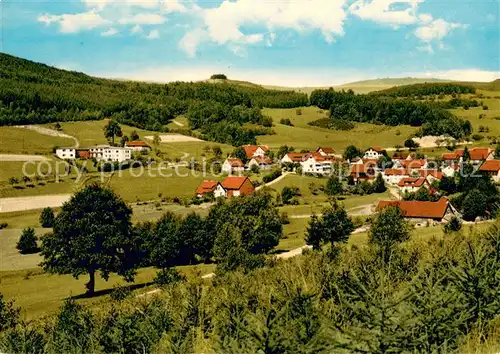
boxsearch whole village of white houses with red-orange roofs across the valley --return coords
[55,140,500,225]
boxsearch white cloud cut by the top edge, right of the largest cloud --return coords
[349,0,422,26]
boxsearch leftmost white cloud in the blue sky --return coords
[38,11,110,33]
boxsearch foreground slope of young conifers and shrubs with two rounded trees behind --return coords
[0,201,500,354]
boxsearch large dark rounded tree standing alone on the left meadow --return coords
[41,184,137,295]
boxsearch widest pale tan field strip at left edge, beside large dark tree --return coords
[0,194,71,213]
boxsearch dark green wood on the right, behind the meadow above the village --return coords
[310,89,472,138]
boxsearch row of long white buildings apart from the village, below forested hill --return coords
[56,140,151,162]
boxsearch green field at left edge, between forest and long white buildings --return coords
[0,127,74,154]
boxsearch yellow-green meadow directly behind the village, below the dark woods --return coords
[257,107,418,152]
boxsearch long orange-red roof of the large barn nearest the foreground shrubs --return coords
[377,197,448,219]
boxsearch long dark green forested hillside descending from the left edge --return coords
[0,54,308,145]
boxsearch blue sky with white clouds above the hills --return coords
[0,0,500,87]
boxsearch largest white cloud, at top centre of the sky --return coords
[181,0,347,54]
